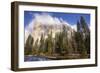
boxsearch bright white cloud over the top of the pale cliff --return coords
[34,13,61,25]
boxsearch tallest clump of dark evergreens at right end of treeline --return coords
[75,16,90,57]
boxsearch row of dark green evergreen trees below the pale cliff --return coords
[24,16,90,57]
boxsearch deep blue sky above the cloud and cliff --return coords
[24,11,90,26]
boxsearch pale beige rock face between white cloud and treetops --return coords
[31,20,75,43]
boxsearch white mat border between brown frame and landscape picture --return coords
[18,5,95,68]
